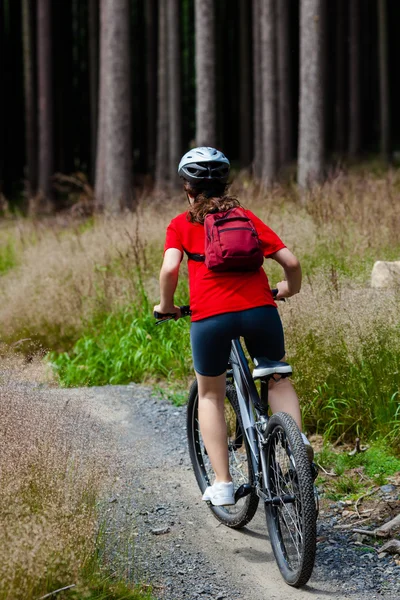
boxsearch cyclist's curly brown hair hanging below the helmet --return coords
[183,181,241,223]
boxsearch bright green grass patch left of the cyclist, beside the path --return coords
[49,294,192,387]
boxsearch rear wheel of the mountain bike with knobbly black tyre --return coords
[264,413,317,587]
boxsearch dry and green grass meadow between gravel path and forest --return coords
[0,171,400,437]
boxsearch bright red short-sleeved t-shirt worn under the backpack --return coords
[164,210,285,321]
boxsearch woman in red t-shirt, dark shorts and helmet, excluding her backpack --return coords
[154,147,313,506]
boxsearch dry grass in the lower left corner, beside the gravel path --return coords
[0,356,109,600]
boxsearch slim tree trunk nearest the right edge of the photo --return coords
[378,0,390,161]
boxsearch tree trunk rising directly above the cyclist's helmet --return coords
[195,0,217,146]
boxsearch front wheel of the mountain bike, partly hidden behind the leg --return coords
[187,381,259,529]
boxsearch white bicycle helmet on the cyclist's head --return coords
[178,146,230,184]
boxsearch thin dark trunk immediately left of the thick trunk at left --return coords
[88,0,99,181]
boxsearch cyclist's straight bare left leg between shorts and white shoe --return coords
[196,373,232,482]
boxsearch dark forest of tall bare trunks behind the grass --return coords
[0,0,400,213]
